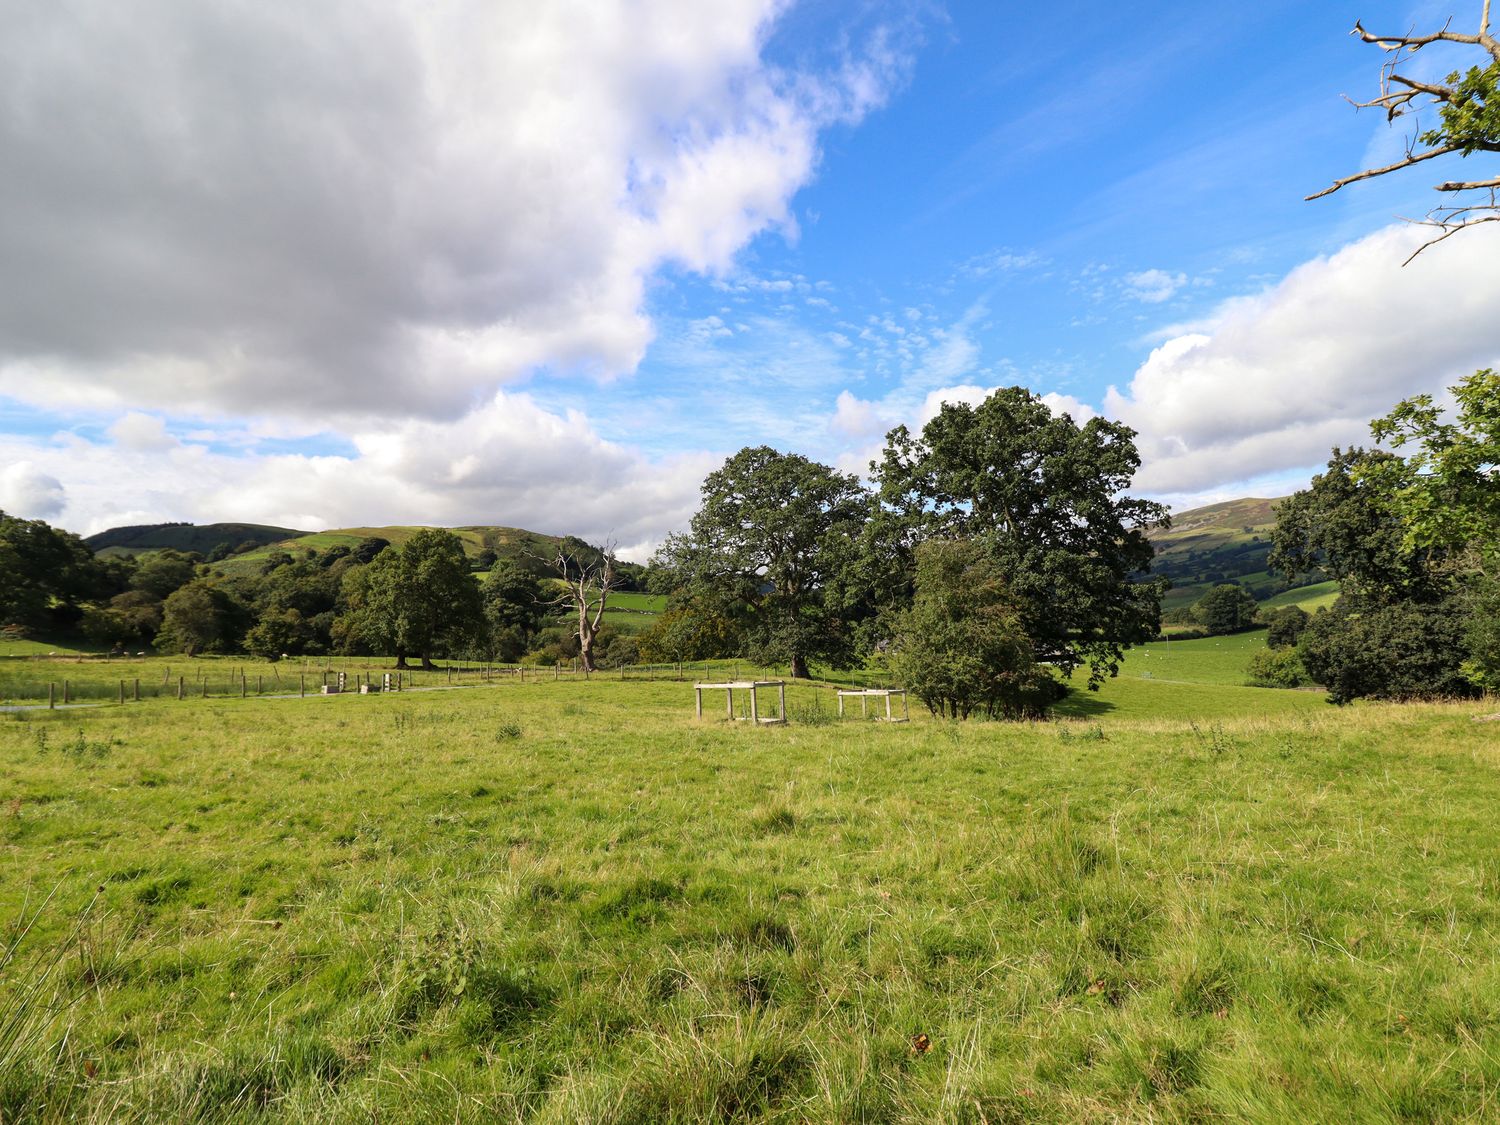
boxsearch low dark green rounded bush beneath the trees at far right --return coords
[1296,599,1476,704]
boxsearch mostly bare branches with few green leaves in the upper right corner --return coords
[1307,0,1500,264]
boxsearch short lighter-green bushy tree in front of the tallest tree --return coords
[891,540,1061,719]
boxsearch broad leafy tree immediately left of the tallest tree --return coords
[660,446,869,678]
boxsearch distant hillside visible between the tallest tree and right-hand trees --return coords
[1151,498,1314,609]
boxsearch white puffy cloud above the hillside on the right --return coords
[1104,224,1500,494]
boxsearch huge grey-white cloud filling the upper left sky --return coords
[0,0,903,423]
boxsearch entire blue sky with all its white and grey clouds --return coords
[0,0,1500,555]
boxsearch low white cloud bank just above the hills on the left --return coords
[0,392,717,558]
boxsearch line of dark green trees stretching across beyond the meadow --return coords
[0,379,1500,717]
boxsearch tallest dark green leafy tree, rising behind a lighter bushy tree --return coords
[873,387,1167,689]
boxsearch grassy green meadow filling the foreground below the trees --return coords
[0,648,1500,1122]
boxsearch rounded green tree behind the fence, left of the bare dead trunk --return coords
[340,528,483,669]
